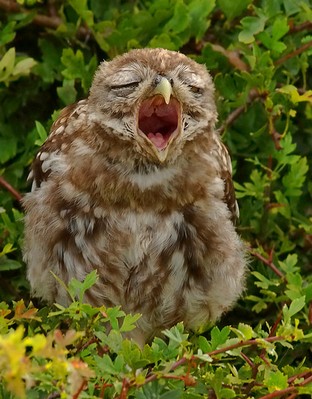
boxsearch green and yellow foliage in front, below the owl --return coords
[0,272,312,399]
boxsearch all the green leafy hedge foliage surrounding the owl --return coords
[0,0,312,399]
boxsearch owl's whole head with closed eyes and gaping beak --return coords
[89,49,216,163]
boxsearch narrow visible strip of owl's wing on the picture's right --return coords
[216,140,239,224]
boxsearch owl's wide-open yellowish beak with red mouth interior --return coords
[138,77,181,162]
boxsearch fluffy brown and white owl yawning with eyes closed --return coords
[24,49,246,344]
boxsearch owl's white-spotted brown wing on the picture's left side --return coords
[28,100,86,191]
